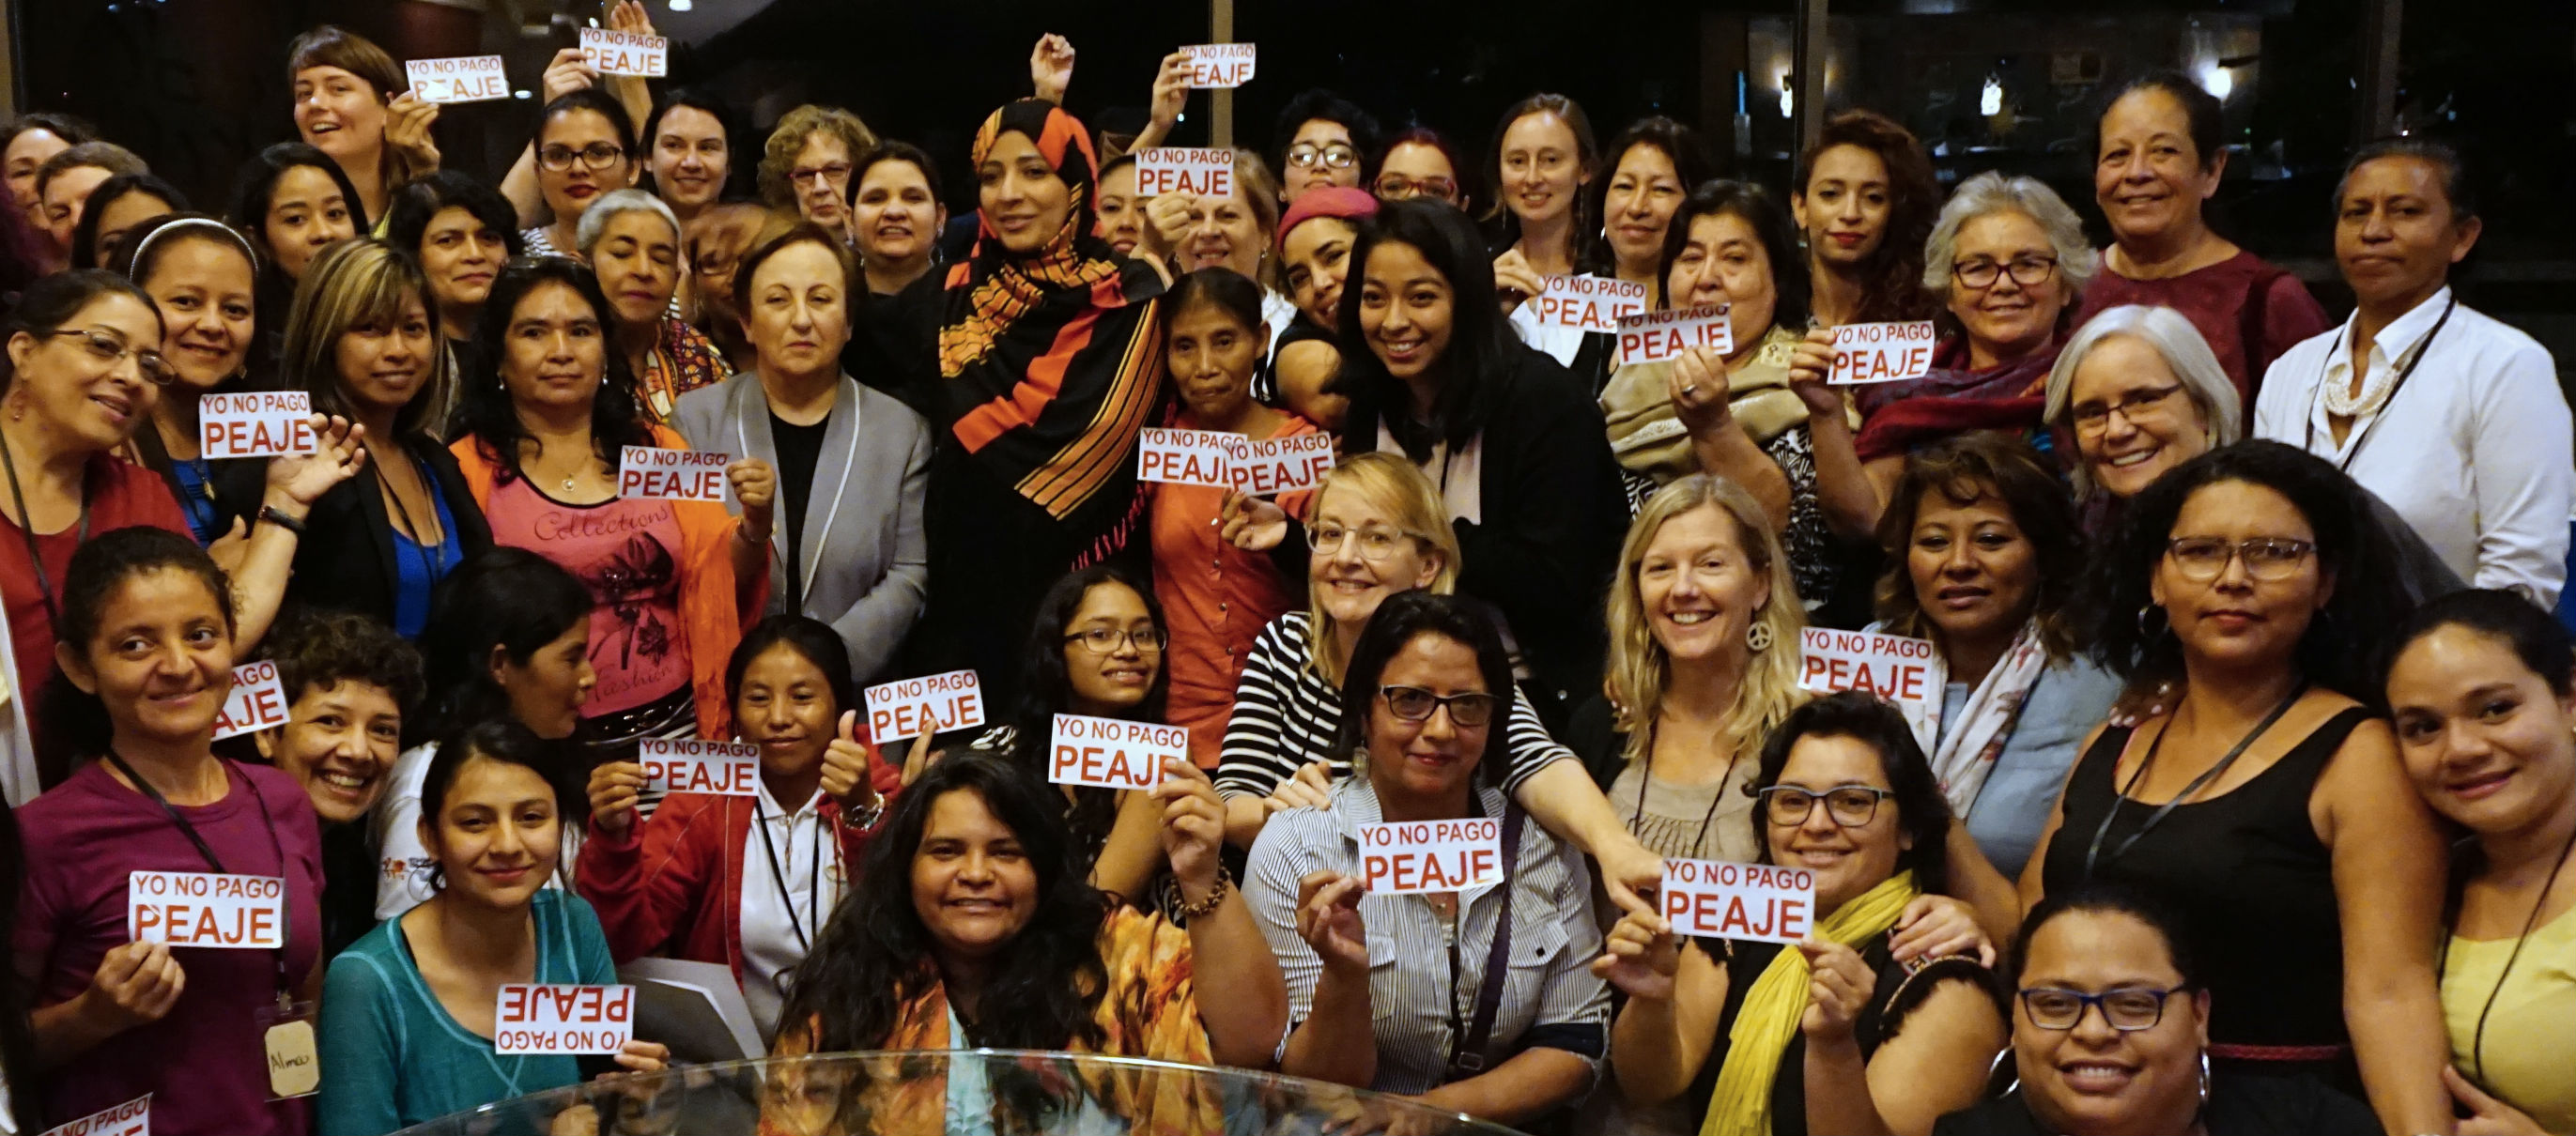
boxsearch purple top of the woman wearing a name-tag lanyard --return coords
[13,762,322,1136]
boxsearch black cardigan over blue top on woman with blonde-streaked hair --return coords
[216,438,492,626]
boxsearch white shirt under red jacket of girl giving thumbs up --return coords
[742,780,842,1040]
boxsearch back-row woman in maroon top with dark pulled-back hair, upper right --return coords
[2074,72,2331,409]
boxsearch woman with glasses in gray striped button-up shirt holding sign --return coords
[1244,592,1610,1126]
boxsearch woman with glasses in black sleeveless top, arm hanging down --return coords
[2022,440,2450,1133]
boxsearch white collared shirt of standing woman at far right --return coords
[2254,288,2576,608]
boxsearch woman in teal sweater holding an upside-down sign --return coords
[319,721,670,1136]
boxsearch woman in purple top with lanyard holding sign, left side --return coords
[10,526,322,1133]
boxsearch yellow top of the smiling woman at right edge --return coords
[2442,896,2576,1131]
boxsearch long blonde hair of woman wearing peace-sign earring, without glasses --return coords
[1602,474,1806,762]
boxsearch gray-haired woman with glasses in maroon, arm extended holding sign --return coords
[1790,173,2102,538]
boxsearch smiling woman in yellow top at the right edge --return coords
[2385,590,2576,1136]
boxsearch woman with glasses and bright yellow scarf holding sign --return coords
[1592,693,2004,1136]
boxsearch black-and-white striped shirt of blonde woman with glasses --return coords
[1216,610,1574,799]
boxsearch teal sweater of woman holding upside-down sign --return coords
[316,891,618,1136]
